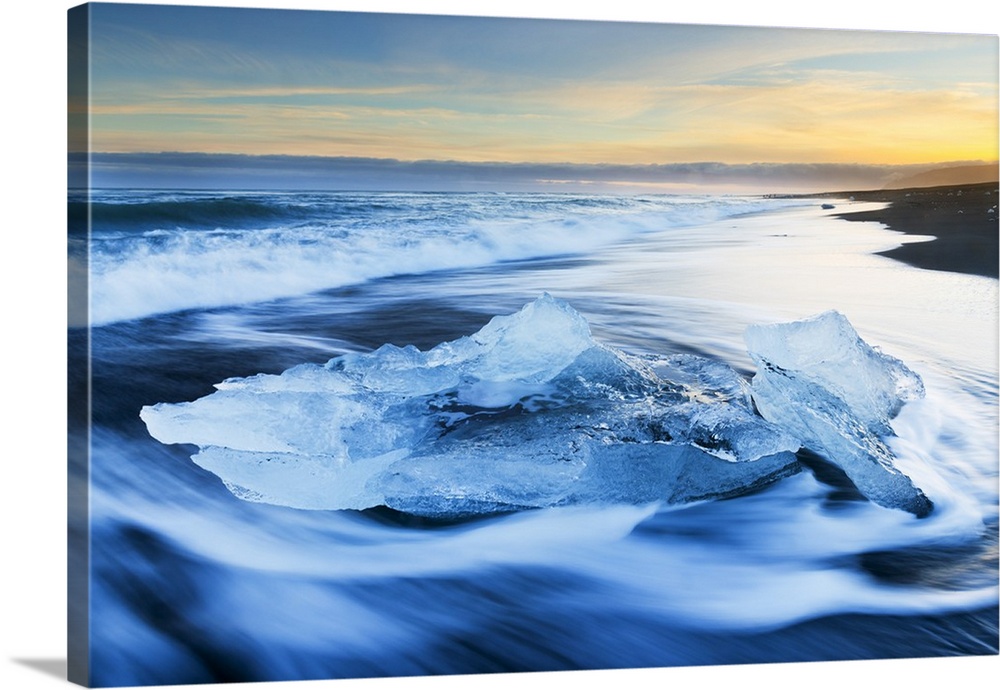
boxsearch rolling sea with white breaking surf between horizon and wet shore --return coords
[84,192,801,325]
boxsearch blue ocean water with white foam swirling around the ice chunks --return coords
[69,190,998,686]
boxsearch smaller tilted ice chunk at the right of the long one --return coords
[745,311,932,516]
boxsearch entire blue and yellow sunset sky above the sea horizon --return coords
[71,4,998,192]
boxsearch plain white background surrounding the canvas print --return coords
[0,0,1000,690]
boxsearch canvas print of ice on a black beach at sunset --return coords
[68,3,1000,687]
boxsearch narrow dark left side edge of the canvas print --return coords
[66,5,91,686]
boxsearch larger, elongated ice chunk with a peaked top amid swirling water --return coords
[141,295,799,516]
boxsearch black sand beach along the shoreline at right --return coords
[821,182,1000,278]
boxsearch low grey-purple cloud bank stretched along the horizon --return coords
[70,153,992,193]
